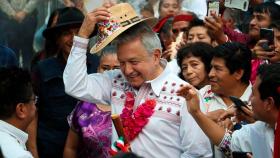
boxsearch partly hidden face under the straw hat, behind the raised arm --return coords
[97,54,120,73]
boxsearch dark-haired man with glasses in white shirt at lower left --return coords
[0,68,36,158]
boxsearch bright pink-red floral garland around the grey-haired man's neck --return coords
[120,92,156,141]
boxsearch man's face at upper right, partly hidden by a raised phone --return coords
[249,12,271,40]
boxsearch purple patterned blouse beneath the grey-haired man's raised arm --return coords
[68,102,112,158]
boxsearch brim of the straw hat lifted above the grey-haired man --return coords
[90,18,157,54]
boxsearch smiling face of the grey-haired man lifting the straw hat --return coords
[117,39,161,88]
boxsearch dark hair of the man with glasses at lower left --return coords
[0,67,33,119]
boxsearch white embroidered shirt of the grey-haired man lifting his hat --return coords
[63,36,212,158]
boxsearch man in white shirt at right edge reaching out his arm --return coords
[179,63,280,158]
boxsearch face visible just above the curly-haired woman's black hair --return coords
[187,26,212,44]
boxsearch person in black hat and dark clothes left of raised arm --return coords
[30,7,98,158]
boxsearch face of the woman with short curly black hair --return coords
[181,56,208,88]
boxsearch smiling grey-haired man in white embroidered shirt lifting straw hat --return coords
[63,4,212,158]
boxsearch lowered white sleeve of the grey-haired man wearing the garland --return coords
[180,97,212,158]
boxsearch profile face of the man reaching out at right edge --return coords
[250,77,265,121]
